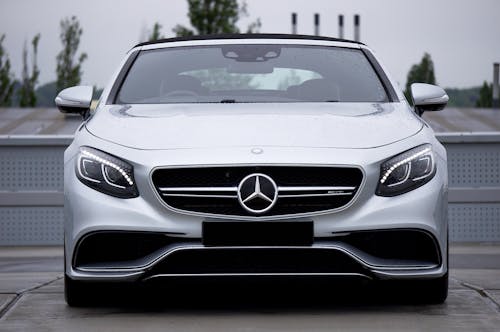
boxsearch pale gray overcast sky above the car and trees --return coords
[0,0,500,87]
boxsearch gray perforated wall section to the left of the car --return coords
[0,135,73,245]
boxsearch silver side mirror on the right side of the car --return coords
[411,83,450,115]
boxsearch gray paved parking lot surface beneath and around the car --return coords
[0,244,500,331]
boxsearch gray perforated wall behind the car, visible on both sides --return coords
[0,132,500,246]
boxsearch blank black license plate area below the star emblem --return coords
[202,221,314,246]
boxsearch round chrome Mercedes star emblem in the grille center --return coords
[238,173,278,214]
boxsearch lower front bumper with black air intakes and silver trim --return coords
[66,229,446,281]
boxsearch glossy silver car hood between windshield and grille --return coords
[86,103,423,149]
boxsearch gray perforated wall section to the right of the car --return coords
[438,132,500,242]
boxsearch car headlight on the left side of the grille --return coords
[76,146,139,198]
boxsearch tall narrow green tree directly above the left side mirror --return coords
[56,16,87,92]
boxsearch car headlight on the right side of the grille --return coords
[376,144,436,196]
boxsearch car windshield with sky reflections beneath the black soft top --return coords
[116,44,388,104]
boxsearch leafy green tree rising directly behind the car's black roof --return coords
[173,0,261,37]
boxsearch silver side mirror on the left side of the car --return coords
[55,86,94,118]
